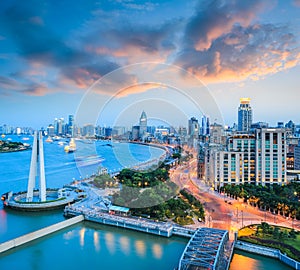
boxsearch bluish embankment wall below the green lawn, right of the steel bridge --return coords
[234,241,300,269]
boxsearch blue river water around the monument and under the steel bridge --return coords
[0,136,290,270]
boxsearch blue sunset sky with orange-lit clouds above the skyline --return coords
[0,0,300,128]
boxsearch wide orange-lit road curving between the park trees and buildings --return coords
[170,154,300,238]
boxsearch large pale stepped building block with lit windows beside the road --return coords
[208,128,287,188]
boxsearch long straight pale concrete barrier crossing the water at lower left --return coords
[0,215,84,253]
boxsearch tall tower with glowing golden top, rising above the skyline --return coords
[238,98,252,132]
